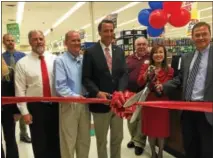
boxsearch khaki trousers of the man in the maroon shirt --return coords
[127,110,146,148]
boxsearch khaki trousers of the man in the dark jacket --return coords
[93,112,123,158]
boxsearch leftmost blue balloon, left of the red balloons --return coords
[138,9,152,26]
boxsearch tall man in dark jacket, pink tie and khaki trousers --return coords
[82,20,128,158]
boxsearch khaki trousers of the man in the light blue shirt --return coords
[59,103,90,158]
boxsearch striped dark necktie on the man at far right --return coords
[185,52,202,101]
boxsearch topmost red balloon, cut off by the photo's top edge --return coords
[163,2,182,14]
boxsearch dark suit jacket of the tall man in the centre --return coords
[82,43,128,113]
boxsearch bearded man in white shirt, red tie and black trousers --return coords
[15,30,60,158]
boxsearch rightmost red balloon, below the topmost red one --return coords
[169,8,191,27]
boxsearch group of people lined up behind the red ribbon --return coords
[2,20,213,158]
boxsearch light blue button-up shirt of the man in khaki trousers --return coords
[54,52,83,97]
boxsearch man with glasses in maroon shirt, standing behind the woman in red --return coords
[127,37,149,155]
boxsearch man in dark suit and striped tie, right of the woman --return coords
[157,22,213,158]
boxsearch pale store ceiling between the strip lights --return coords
[2,2,212,50]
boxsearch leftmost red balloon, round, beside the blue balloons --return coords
[149,9,168,29]
